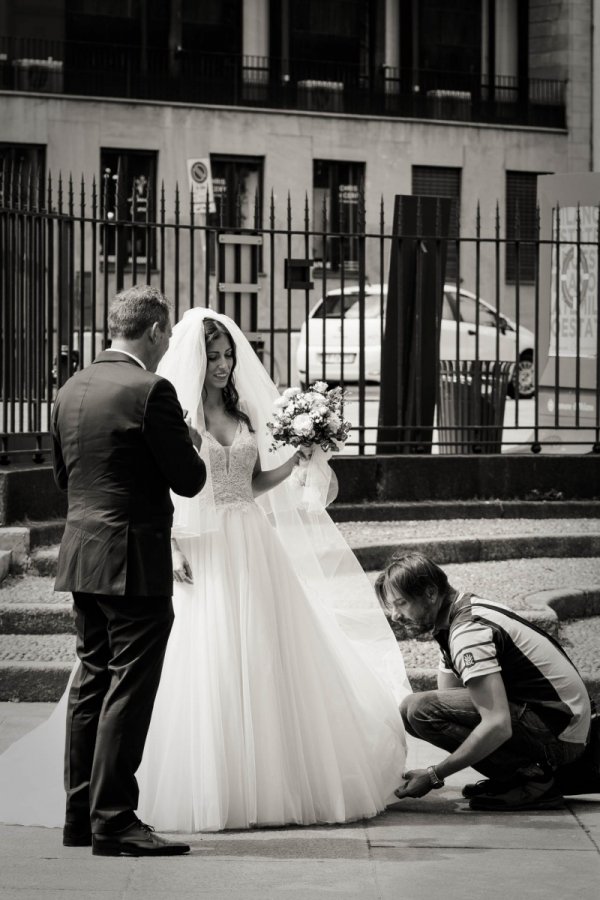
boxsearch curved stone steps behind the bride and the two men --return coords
[0,501,600,702]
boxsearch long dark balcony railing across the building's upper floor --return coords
[0,37,565,128]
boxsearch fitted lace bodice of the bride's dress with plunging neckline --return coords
[203,422,258,506]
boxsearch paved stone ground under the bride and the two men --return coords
[0,703,600,900]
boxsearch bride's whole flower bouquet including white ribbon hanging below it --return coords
[267,381,352,512]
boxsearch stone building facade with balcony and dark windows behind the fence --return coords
[0,0,600,378]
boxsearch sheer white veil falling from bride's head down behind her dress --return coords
[158,307,410,698]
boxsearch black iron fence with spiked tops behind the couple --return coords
[0,178,600,464]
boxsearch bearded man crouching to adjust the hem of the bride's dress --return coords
[376,553,591,810]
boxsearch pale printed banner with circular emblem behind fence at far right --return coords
[549,206,598,359]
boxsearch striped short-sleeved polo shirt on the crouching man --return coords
[435,593,591,744]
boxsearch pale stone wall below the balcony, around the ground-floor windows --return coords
[0,93,571,327]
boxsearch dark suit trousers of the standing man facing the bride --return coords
[65,593,174,834]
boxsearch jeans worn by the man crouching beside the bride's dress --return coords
[400,688,584,781]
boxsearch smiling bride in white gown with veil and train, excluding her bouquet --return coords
[0,308,410,833]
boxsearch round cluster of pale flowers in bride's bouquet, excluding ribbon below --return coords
[267,381,352,453]
